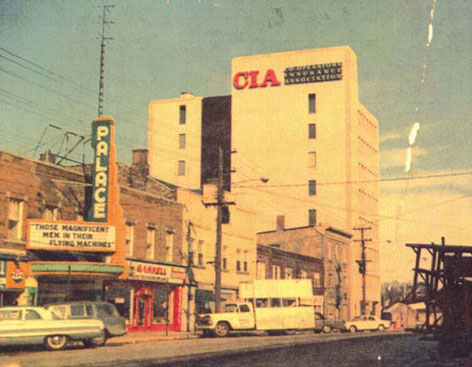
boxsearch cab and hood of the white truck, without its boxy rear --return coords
[197,302,256,337]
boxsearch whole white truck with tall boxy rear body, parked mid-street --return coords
[197,279,315,337]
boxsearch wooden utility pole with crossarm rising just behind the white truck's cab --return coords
[205,147,235,312]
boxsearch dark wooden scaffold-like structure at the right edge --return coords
[406,238,472,346]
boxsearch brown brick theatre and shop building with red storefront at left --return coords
[0,150,186,330]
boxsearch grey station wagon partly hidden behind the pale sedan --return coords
[45,301,127,346]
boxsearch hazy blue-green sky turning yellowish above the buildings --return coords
[0,0,472,281]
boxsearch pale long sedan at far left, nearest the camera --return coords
[0,306,105,350]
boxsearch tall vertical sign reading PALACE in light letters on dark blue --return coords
[88,120,112,222]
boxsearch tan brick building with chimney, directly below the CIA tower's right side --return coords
[257,216,351,320]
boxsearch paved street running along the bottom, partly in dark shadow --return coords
[0,332,470,367]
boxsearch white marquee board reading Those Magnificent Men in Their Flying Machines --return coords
[26,220,116,252]
